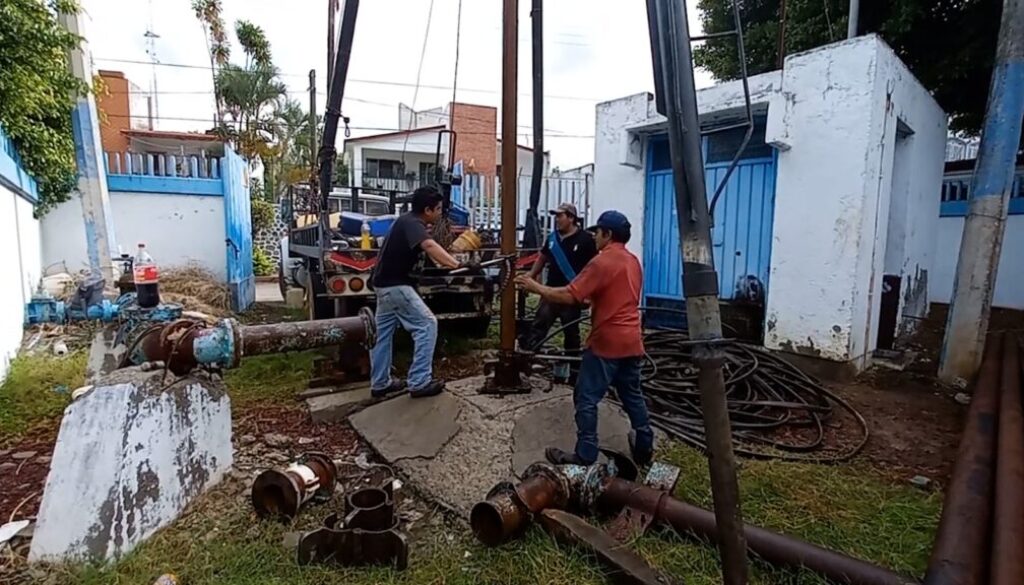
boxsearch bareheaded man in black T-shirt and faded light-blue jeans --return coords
[370,186,459,398]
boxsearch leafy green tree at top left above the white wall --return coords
[0,0,88,215]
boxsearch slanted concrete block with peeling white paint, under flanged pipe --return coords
[29,368,232,561]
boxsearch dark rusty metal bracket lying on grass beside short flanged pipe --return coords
[297,479,409,571]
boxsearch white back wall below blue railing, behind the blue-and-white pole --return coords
[42,192,227,279]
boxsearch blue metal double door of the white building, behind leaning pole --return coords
[643,133,775,305]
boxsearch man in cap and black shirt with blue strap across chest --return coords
[522,203,597,351]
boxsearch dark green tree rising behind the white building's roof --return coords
[693,0,1001,133]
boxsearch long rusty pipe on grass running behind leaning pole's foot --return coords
[597,477,916,585]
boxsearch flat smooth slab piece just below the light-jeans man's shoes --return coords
[349,392,462,461]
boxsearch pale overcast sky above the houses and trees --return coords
[82,0,711,168]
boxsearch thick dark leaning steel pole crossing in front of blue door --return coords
[647,0,753,585]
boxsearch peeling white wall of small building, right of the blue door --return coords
[765,36,946,368]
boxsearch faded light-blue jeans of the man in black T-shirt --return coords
[370,287,437,390]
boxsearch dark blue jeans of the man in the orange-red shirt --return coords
[572,349,654,464]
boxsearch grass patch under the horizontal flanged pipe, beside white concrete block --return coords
[224,350,319,407]
